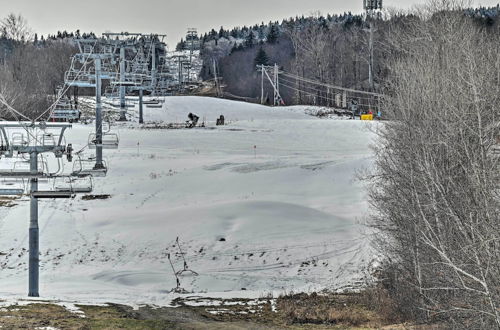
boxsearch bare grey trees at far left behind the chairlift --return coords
[0,14,88,120]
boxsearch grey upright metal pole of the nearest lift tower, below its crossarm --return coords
[28,151,40,297]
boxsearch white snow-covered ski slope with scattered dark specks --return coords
[0,97,376,305]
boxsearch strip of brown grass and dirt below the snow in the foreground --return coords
[0,293,422,330]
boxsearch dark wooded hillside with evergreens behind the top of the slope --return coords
[189,6,500,105]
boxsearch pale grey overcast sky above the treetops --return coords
[0,0,499,48]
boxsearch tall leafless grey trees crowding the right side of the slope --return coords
[370,0,500,329]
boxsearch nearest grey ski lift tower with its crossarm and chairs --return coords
[0,122,73,297]
